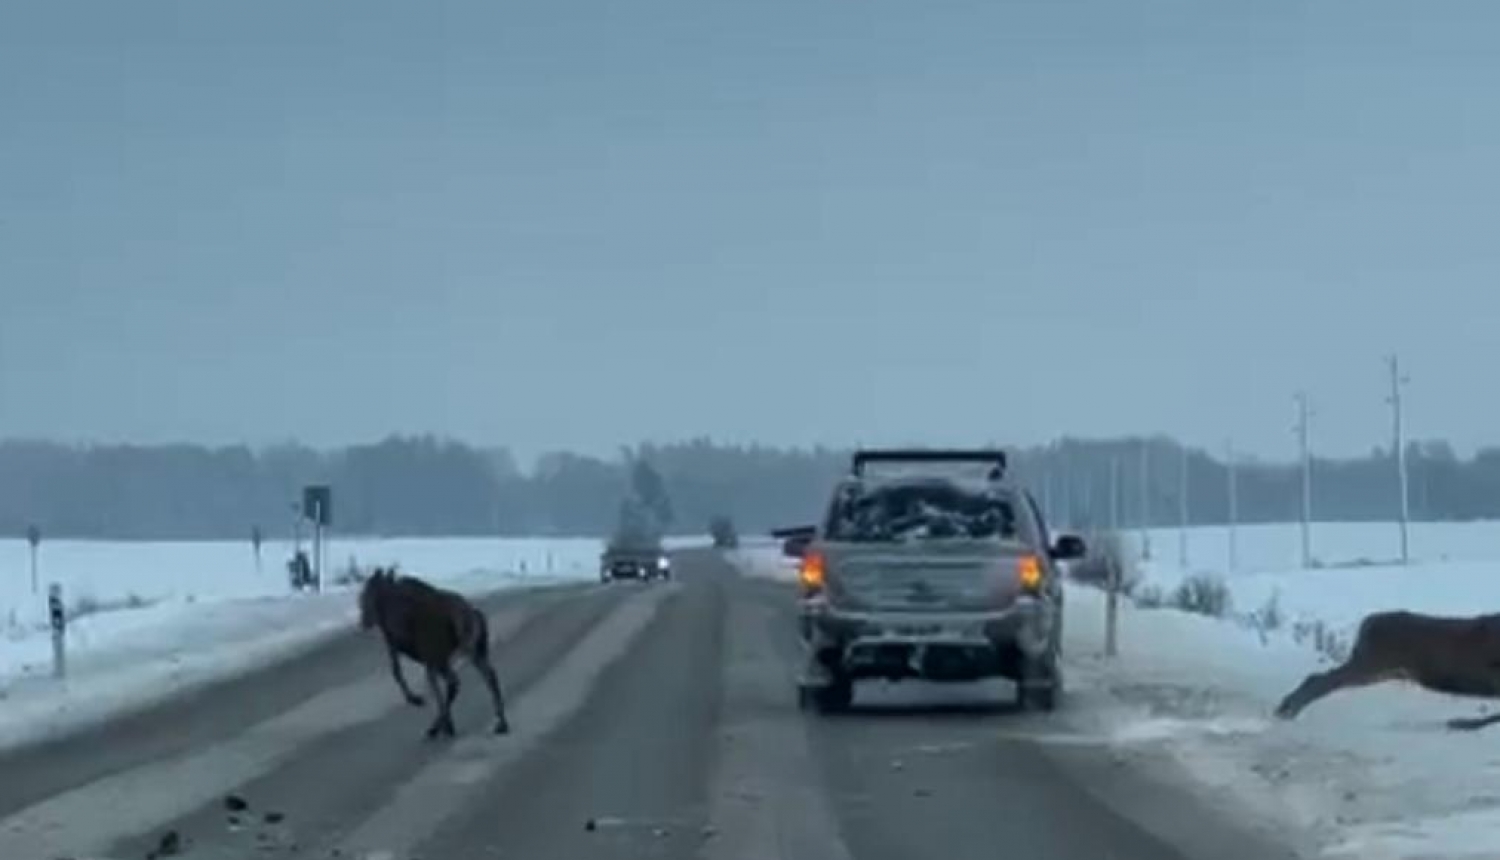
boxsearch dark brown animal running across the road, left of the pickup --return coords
[360,567,510,737]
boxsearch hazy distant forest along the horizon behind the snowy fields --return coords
[0,437,1500,539]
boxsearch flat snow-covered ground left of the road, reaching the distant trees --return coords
[0,539,600,747]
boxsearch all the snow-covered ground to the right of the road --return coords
[741,522,1500,860]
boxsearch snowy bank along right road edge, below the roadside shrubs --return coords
[1067,588,1500,858]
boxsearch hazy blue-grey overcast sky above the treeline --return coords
[0,0,1500,456]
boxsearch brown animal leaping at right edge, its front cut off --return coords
[1277,612,1500,731]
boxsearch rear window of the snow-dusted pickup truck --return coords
[827,480,1022,542]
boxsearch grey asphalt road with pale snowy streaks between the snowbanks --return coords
[0,551,1292,860]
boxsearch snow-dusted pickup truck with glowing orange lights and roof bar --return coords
[783,450,1085,711]
